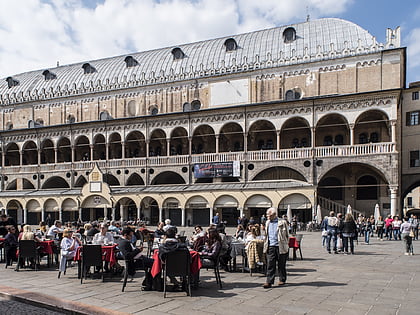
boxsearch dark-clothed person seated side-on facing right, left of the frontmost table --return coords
[118,227,153,290]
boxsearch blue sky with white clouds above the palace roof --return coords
[0,0,420,86]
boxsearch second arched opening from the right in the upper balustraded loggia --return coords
[315,114,350,146]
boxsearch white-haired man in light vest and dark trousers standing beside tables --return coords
[263,208,289,289]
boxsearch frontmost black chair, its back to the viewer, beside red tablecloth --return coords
[162,250,191,298]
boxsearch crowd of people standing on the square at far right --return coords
[321,211,419,255]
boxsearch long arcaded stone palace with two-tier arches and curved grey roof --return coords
[0,19,405,225]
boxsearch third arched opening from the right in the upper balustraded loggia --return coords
[280,117,312,149]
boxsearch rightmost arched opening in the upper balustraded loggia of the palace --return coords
[354,110,391,144]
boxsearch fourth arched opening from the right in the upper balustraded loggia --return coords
[248,120,277,151]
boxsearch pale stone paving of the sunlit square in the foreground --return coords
[0,232,420,315]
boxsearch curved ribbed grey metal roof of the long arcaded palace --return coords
[0,18,383,104]
